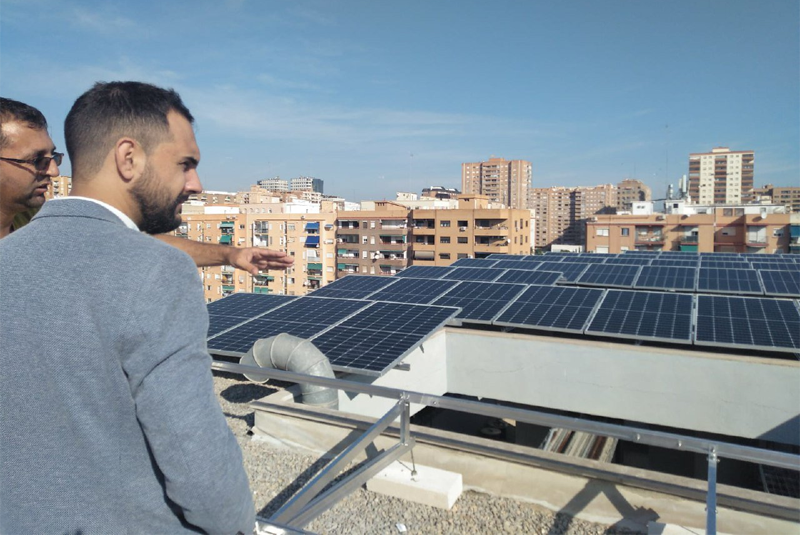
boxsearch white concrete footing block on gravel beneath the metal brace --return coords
[367,462,463,509]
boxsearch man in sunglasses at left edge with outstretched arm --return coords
[0,97,294,275]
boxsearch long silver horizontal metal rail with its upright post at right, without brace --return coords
[211,361,800,535]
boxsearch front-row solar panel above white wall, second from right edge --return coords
[586,290,694,344]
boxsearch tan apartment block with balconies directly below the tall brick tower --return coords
[410,195,534,266]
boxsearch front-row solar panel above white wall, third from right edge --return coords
[493,286,603,333]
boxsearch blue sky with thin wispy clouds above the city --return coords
[0,0,800,201]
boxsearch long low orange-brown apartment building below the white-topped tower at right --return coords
[586,205,791,253]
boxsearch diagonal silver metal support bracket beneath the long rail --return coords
[270,399,414,527]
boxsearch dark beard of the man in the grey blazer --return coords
[131,162,189,234]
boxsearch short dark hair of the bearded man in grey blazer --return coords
[64,82,194,176]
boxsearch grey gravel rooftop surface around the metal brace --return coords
[214,372,637,535]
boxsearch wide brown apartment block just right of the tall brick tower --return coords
[528,184,617,249]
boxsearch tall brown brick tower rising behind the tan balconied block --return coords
[461,157,532,209]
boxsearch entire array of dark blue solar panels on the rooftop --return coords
[208,251,800,376]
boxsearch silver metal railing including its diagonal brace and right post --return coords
[211,361,800,535]
